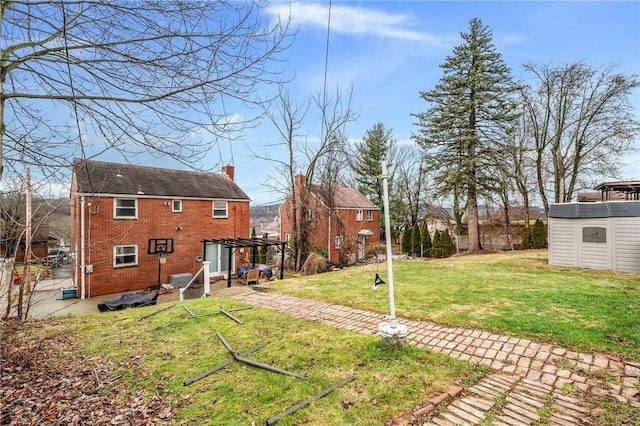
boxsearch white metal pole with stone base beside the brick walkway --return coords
[378,157,409,347]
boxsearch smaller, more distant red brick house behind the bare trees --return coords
[279,174,380,264]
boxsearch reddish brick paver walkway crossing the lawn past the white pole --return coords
[231,292,640,426]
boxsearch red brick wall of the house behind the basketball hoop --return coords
[71,197,249,296]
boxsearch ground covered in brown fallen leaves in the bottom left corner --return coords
[0,320,176,426]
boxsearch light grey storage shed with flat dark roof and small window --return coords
[548,201,640,272]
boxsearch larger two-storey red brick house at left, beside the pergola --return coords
[71,159,250,298]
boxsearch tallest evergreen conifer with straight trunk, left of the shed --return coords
[414,18,518,252]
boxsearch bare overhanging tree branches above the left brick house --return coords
[0,0,290,181]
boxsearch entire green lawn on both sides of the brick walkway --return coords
[15,251,640,426]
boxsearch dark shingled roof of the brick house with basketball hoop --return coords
[73,158,249,200]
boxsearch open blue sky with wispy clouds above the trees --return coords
[82,1,640,204]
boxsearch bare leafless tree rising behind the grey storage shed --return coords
[524,62,640,212]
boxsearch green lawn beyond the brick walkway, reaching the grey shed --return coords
[273,250,640,361]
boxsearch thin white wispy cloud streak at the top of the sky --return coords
[267,3,451,47]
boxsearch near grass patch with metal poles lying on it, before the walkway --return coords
[50,299,480,426]
